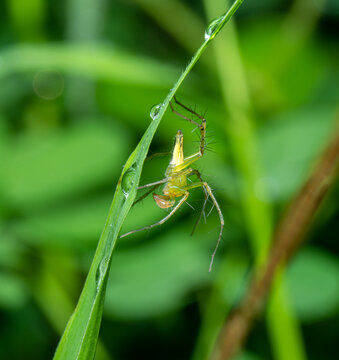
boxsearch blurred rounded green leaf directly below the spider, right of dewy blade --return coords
[105,226,213,320]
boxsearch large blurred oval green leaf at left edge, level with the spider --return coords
[0,120,129,211]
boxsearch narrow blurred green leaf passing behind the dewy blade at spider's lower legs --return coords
[12,193,161,249]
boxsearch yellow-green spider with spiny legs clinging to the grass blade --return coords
[120,98,224,271]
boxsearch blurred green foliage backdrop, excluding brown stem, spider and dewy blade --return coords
[0,0,339,360]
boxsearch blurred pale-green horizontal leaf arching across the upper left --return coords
[0,44,179,86]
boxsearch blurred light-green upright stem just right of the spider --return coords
[199,0,305,360]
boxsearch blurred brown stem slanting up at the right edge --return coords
[215,121,339,360]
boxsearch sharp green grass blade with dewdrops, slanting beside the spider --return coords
[54,0,243,360]
